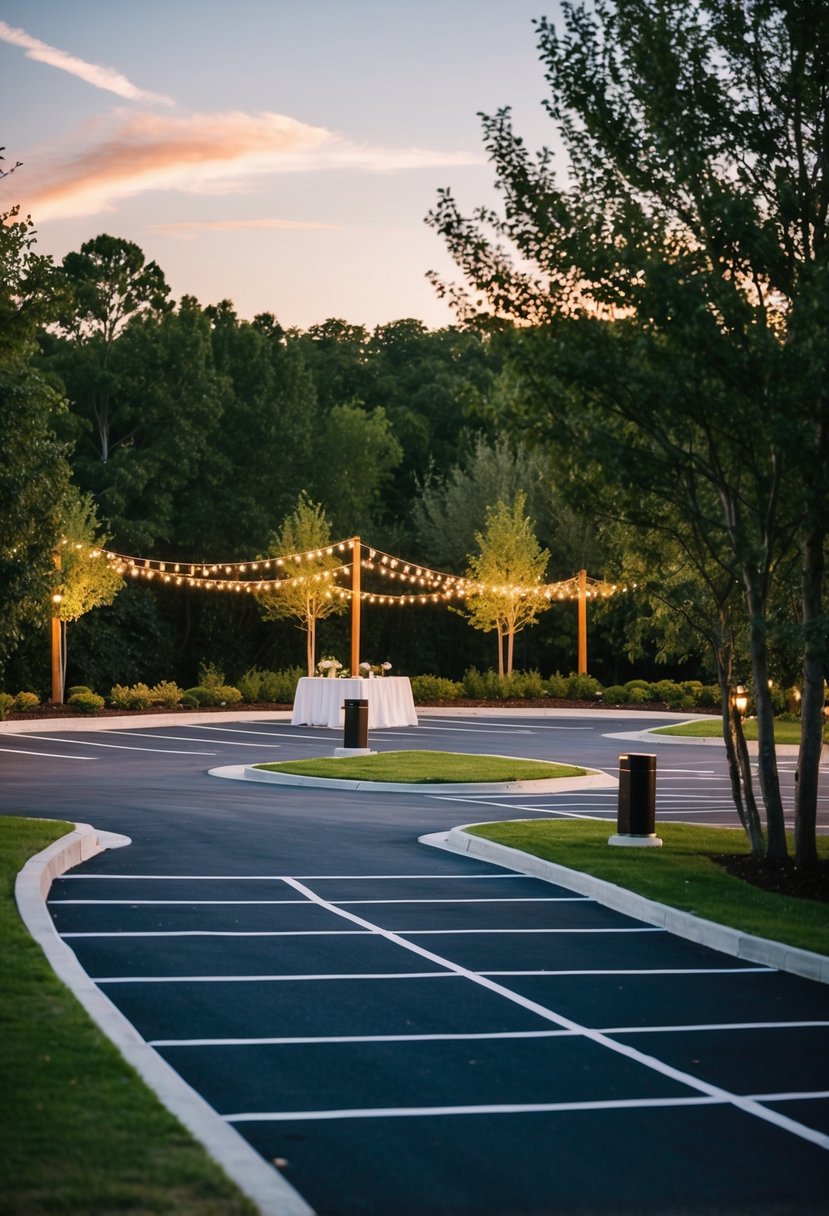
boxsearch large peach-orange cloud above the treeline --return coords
[14,112,483,221]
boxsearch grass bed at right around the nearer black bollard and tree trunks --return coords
[469,820,829,955]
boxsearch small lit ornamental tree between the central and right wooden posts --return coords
[458,491,549,676]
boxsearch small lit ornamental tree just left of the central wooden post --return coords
[256,492,345,676]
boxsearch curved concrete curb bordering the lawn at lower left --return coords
[15,823,314,1216]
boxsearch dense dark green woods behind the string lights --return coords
[4,224,656,692]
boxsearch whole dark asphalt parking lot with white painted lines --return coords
[0,714,829,1216]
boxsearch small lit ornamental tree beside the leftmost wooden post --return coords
[52,491,124,700]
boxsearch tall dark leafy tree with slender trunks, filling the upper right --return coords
[430,0,829,865]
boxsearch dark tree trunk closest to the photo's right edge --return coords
[795,528,829,867]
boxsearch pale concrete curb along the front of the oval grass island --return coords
[208,764,617,794]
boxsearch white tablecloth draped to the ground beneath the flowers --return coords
[291,676,417,731]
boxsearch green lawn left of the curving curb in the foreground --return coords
[0,818,255,1216]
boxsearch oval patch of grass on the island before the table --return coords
[254,751,586,784]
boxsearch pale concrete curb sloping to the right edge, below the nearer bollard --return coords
[419,823,829,984]
